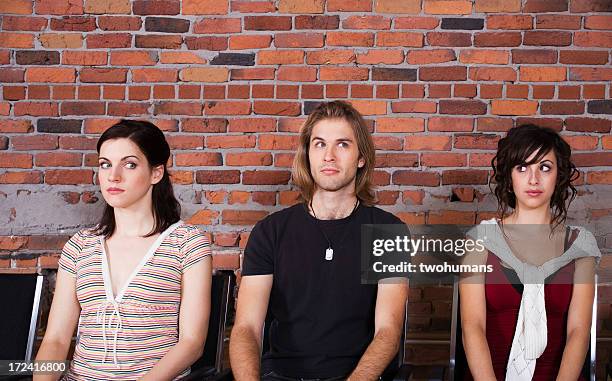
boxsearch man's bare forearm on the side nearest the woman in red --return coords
[348,280,408,381]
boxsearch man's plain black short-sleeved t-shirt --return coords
[242,204,402,378]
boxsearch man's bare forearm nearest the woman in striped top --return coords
[230,274,272,381]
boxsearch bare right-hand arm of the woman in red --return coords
[557,257,597,381]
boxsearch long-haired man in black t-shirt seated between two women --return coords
[230,101,408,381]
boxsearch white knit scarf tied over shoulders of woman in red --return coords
[468,219,601,381]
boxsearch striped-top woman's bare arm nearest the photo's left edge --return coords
[34,268,81,381]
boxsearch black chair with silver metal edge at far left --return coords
[0,273,43,361]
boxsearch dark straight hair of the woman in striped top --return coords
[94,119,181,238]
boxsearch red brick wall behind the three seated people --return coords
[0,0,612,376]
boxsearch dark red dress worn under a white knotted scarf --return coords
[466,253,586,381]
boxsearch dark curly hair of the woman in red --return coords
[489,124,579,229]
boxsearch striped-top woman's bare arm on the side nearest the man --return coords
[141,256,212,381]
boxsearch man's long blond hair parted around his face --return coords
[292,101,376,205]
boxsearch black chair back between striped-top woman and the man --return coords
[182,271,236,381]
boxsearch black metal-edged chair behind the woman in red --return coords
[448,276,597,381]
